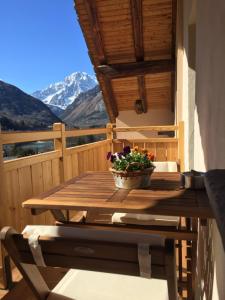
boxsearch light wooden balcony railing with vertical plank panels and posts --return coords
[0,123,184,230]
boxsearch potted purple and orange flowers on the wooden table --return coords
[107,146,155,189]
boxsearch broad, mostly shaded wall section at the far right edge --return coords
[194,0,225,300]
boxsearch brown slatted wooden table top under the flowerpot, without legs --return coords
[22,171,214,218]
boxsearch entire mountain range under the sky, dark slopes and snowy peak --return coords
[0,72,108,130]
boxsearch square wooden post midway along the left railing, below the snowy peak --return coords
[53,123,66,182]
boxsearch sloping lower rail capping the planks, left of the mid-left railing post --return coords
[4,150,62,172]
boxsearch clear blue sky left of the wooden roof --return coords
[0,0,94,93]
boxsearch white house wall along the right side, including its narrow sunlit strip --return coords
[182,0,225,300]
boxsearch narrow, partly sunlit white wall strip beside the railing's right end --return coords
[176,0,196,170]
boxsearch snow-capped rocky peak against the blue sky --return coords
[32,72,97,109]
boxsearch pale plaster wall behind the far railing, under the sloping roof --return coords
[116,109,174,139]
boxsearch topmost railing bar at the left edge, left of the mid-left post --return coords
[1,131,61,145]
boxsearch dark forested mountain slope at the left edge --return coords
[0,80,61,130]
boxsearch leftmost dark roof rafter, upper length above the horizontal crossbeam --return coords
[83,0,107,64]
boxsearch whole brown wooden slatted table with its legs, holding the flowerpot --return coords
[23,172,214,299]
